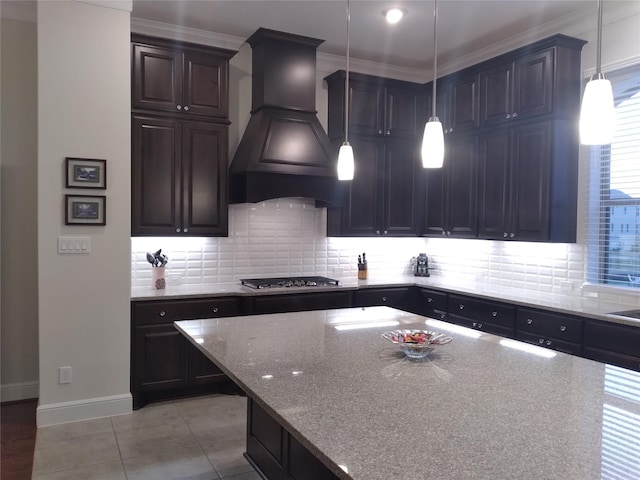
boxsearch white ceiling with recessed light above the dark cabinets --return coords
[132,0,609,69]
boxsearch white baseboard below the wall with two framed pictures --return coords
[36,393,133,427]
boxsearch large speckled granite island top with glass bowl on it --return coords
[176,307,640,480]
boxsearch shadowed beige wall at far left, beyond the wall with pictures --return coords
[0,19,38,401]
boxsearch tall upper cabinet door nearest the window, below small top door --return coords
[509,122,553,241]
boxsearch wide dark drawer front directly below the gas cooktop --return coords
[252,292,350,314]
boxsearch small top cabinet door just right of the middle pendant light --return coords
[446,73,480,133]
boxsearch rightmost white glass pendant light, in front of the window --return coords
[580,0,615,145]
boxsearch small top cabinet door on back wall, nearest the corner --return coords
[384,87,422,138]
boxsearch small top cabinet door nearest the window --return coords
[512,48,554,119]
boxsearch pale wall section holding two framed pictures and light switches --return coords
[37,1,131,425]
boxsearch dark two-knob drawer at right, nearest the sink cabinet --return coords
[516,308,583,343]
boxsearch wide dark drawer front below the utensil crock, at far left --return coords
[132,297,240,325]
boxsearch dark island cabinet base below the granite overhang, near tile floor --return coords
[246,399,338,480]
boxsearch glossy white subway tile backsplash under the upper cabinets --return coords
[131,198,639,306]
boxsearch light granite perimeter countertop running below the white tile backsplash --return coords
[131,275,640,326]
